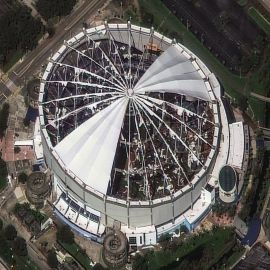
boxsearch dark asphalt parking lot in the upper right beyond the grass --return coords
[162,0,264,71]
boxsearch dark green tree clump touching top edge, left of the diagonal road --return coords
[36,0,77,20]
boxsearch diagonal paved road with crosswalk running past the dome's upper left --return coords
[0,0,106,104]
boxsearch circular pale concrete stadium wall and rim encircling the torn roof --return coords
[39,23,226,243]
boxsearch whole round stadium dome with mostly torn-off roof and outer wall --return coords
[39,23,224,240]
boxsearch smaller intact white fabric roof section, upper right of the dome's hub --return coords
[134,44,210,101]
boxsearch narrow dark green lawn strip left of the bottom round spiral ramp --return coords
[59,241,93,270]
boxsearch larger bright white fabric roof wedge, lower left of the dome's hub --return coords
[55,98,128,194]
